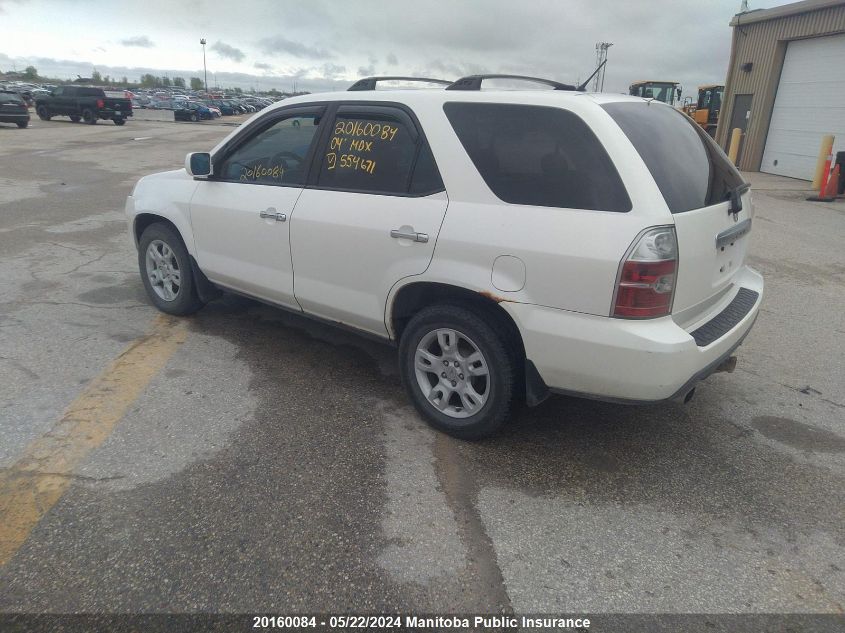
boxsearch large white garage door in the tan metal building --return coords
[760,35,845,180]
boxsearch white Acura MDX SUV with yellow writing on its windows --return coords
[126,77,763,439]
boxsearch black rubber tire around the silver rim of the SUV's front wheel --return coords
[138,223,204,316]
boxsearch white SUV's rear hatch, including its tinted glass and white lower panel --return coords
[603,101,752,322]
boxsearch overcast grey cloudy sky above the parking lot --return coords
[0,0,800,95]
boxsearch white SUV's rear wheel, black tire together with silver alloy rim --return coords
[399,305,514,440]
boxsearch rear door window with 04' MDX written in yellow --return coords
[318,113,418,194]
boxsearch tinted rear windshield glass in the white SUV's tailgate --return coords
[602,102,744,213]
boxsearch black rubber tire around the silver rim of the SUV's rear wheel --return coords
[399,305,515,440]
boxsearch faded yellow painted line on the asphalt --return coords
[0,315,187,565]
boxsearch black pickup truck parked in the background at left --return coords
[35,86,132,125]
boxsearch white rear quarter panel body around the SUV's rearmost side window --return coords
[418,94,672,316]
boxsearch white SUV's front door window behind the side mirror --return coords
[220,113,320,185]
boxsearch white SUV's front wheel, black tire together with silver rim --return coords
[138,224,203,316]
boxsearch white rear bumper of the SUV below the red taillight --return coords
[508,267,763,403]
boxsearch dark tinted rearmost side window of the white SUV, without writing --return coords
[443,103,631,212]
